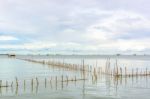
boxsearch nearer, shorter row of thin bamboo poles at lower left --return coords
[0,75,87,94]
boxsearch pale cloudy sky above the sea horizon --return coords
[0,0,150,54]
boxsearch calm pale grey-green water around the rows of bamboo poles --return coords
[0,56,150,99]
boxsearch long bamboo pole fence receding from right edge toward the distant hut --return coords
[15,58,150,78]
